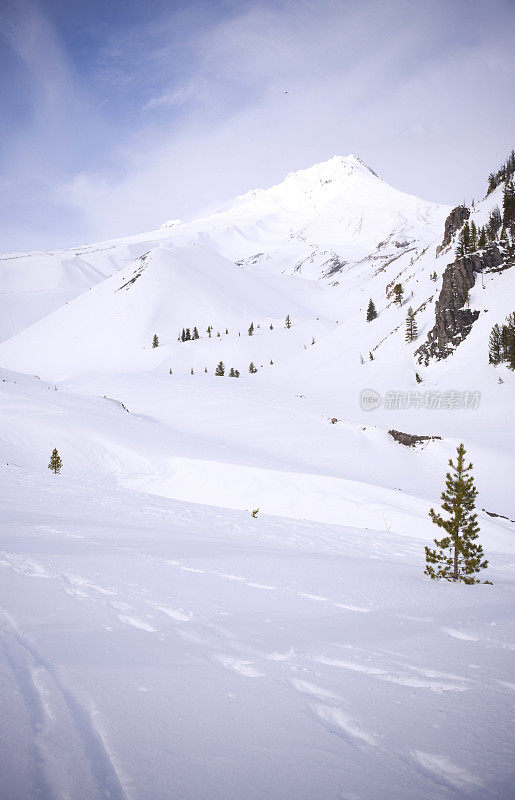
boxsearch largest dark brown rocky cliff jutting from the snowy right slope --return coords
[415,244,504,366]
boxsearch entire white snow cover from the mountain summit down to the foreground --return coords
[0,156,515,800]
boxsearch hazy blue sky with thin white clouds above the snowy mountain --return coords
[0,0,515,252]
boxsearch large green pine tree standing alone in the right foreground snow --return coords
[424,444,488,584]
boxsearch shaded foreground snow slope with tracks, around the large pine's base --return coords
[0,466,515,800]
